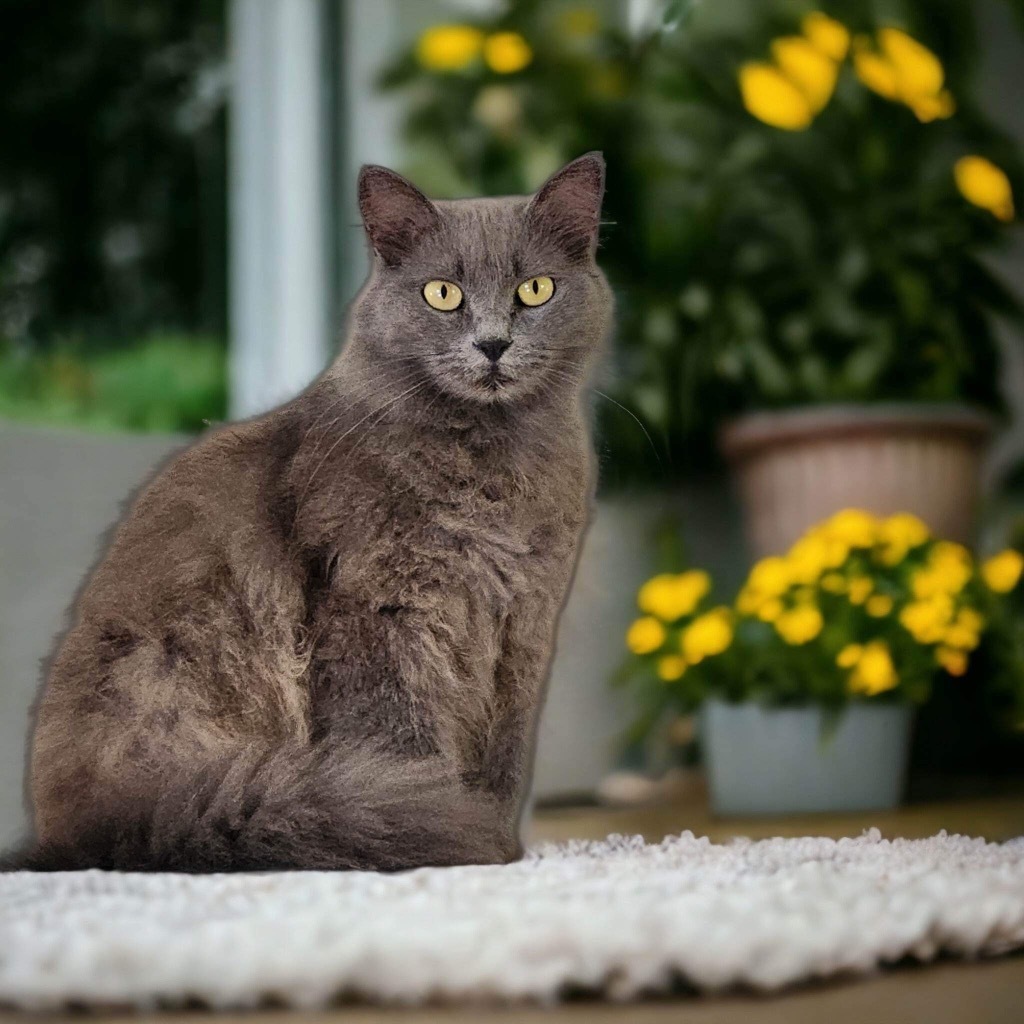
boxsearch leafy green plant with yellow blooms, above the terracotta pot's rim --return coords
[632,2,1024,432]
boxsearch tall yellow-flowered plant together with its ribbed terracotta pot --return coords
[637,3,1021,555]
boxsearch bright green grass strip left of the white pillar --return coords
[0,335,227,433]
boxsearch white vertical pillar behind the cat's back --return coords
[228,0,332,417]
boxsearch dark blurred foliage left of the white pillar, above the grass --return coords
[0,0,226,347]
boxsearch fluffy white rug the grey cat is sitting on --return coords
[0,829,1024,1010]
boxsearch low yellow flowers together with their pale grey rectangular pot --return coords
[626,509,1024,814]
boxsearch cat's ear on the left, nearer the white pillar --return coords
[357,164,440,266]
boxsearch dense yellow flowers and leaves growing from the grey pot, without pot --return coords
[623,509,1024,738]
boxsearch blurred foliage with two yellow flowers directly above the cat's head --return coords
[380,0,634,197]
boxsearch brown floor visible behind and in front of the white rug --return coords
[0,796,1024,1024]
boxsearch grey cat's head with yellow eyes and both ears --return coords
[354,153,611,403]
